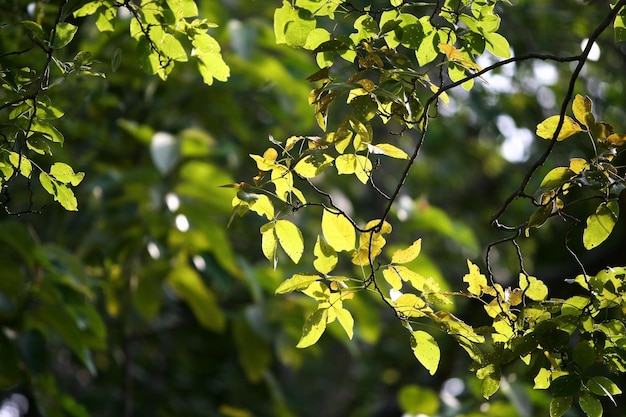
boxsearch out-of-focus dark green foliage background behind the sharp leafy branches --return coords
[0,0,626,417]
